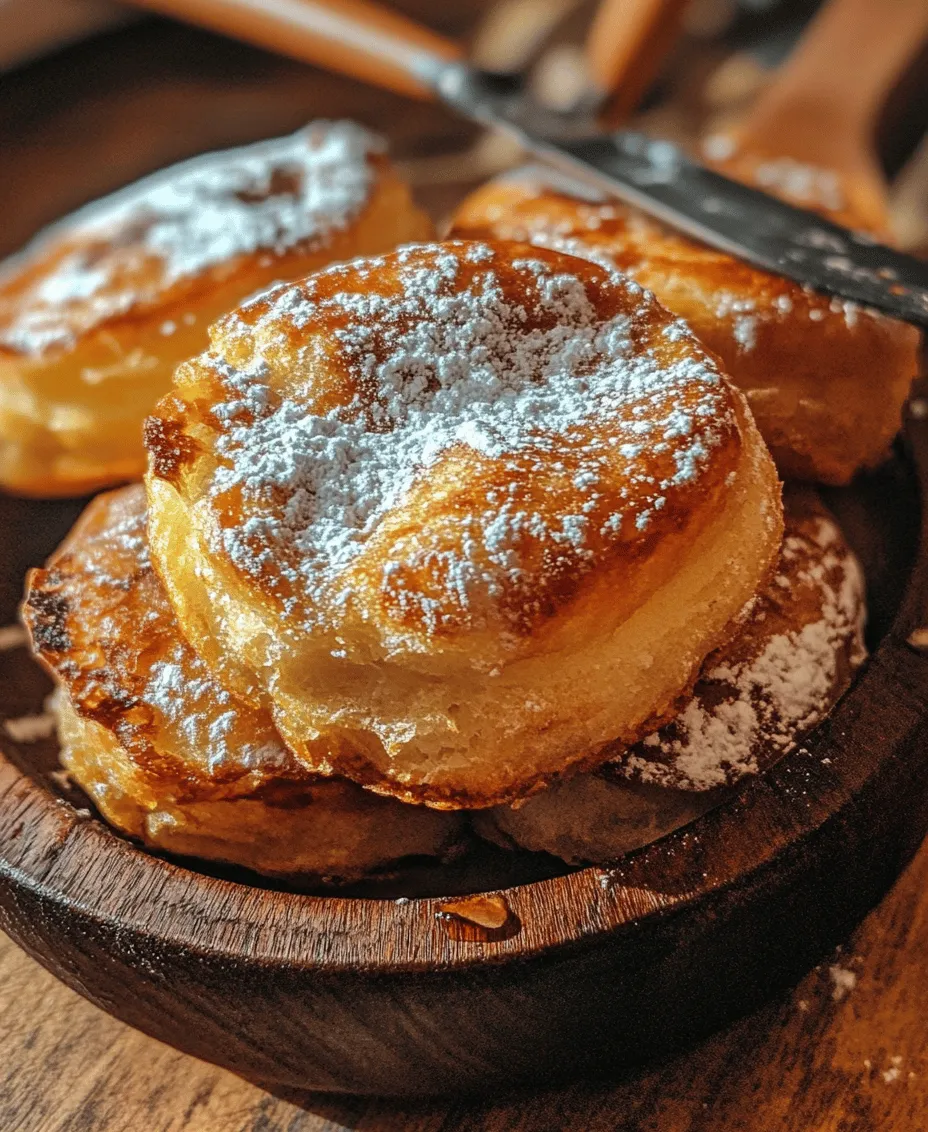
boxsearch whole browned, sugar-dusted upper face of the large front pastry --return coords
[147,243,739,652]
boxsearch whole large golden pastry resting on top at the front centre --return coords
[146,236,782,808]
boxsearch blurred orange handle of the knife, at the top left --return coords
[128,0,461,98]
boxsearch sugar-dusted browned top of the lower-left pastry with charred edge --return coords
[38,486,292,780]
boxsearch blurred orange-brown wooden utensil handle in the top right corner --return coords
[739,0,928,153]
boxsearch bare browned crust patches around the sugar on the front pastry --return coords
[146,241,741,642]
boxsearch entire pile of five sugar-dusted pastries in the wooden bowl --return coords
[12,125,917,881]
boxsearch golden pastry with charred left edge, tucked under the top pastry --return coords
[24,484,459,878]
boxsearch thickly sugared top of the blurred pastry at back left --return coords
[0,121,384,353]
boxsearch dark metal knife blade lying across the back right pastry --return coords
[426,62,928,328]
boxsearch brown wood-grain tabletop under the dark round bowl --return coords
[0,833,928,1132]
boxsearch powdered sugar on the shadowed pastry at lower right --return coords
[615,517,863,790]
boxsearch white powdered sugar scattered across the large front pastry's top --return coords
[209,243,728,642]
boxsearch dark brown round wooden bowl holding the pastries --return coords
[0,384,928,1095]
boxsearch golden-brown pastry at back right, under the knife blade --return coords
[453,166,919,483]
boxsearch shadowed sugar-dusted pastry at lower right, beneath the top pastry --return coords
[476,491,865,864]
